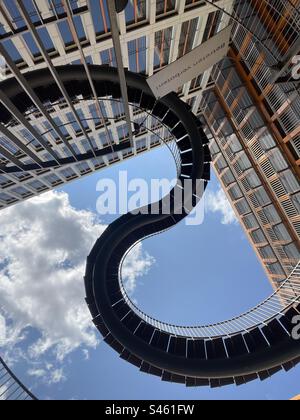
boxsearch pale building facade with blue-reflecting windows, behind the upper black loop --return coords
[0,0,227,208]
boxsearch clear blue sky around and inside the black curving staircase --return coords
[0,146,299,400]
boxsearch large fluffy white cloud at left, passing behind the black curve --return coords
[0,192,153,376]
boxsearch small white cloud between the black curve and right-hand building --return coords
[205,188,237,225]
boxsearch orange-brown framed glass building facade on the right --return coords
[200,1,300,287]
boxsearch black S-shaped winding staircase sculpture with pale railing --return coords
[3,66,300,387]
